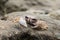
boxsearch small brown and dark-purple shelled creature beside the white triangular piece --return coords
[25,16,48,30]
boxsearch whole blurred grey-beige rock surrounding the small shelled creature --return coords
[0,0,60,40]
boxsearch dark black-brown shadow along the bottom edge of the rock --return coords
[2,32,57,40]
